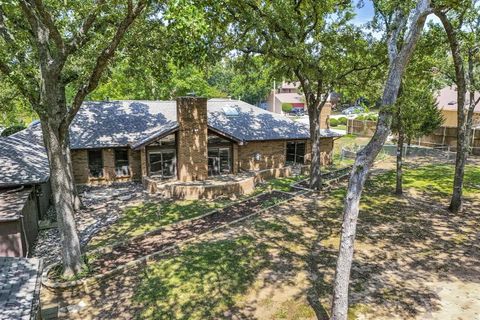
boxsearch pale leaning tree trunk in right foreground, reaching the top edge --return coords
[331,0,430,320]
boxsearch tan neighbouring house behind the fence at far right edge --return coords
[437,87,480,128]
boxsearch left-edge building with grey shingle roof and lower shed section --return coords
[0,124,50,257]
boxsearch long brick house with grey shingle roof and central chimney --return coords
[70,97,339,184]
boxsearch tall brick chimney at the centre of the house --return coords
[177,97,208,182]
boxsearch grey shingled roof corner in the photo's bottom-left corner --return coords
[0,257,41,320]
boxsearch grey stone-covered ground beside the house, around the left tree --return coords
[31,183,152,265]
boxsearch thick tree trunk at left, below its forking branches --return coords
[42,119,83,277]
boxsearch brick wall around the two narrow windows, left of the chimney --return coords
[71,148,142,184]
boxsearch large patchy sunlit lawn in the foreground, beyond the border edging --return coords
[54,161,480,319]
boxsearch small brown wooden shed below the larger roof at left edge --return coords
[0,188,38,257]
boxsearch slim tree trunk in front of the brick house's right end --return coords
[308,106,322,190]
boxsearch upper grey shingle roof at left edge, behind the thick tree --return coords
[0,123,50,187]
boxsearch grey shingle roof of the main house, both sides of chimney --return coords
[70,99,329,149]
